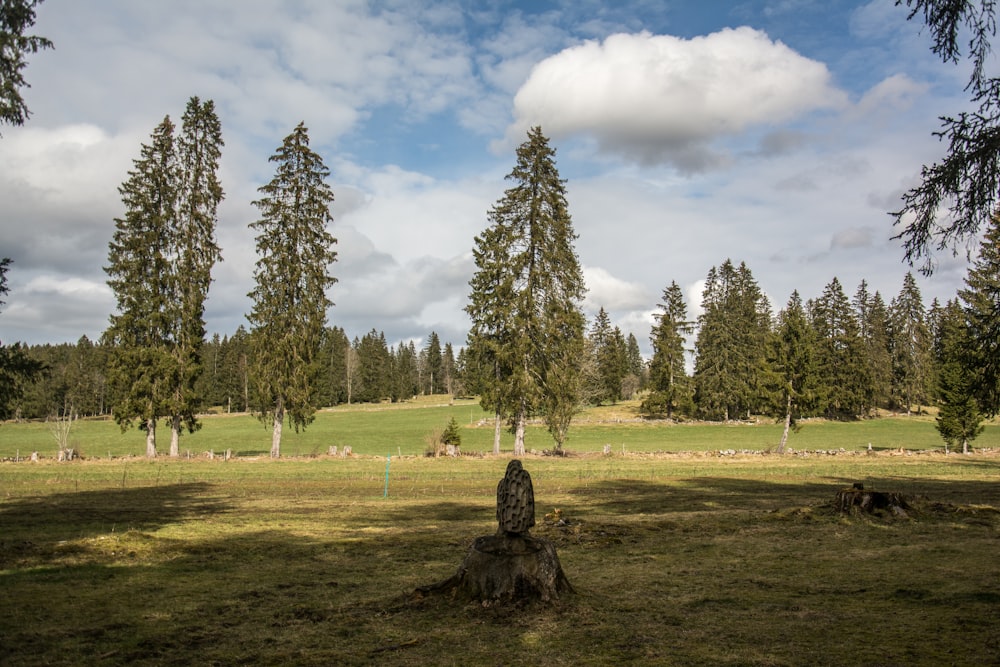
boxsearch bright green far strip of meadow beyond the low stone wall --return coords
[0,396,1000,459]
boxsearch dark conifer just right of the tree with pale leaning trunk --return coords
[808,277,864,418]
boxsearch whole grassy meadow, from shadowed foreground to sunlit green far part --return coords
[0,405,1000,665]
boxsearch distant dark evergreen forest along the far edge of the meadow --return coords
[7,260,976,434]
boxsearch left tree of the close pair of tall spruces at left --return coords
[103,116,180,458]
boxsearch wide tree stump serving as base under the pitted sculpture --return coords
[417,535,573,603]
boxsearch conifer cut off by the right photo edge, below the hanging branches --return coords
[958,214,1000,416]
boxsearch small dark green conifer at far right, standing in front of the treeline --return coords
[935,301,983,454]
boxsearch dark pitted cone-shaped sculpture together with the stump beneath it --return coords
[417,459,573,603]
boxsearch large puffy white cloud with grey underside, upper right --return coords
[508,27,846,172]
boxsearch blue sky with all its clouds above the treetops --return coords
[0,0,984,352]
